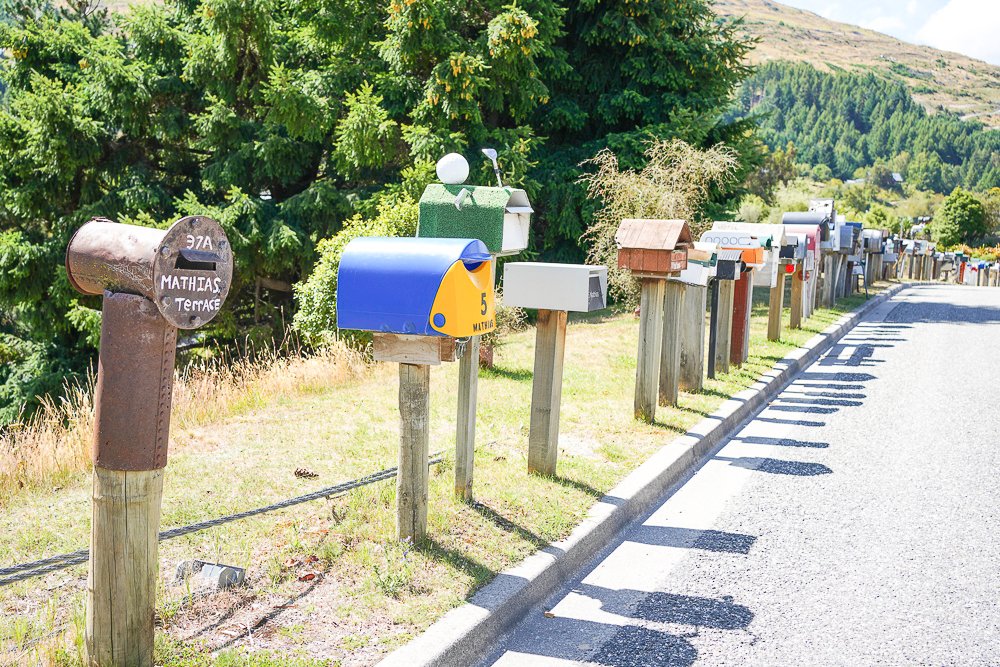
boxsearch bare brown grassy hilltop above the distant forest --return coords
[715,0,1000,127]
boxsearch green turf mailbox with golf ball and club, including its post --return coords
[417,151,534,500]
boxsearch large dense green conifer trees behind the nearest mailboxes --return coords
[0,0,757,423]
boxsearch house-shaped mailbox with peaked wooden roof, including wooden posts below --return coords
[615,219,692,422]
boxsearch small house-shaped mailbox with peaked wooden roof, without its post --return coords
[615,219,692,279]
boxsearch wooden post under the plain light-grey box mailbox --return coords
[528,310,567,476]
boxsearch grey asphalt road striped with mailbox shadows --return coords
[484,286,1000,667]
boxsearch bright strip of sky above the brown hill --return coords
[778,0,1000,65]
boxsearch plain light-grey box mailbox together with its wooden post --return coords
[503,262,608,476]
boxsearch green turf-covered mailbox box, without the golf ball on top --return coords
[417,183,534,257]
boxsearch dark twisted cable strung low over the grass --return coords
[0,452,444,587]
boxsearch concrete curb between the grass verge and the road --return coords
[379,284,908,667]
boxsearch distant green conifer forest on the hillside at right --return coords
[736,63,1000,192]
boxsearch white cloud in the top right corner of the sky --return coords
[916,0,1000,65]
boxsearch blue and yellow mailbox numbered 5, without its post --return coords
[337,237,496,338]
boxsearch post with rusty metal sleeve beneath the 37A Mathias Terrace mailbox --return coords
[85,292,177,667]
